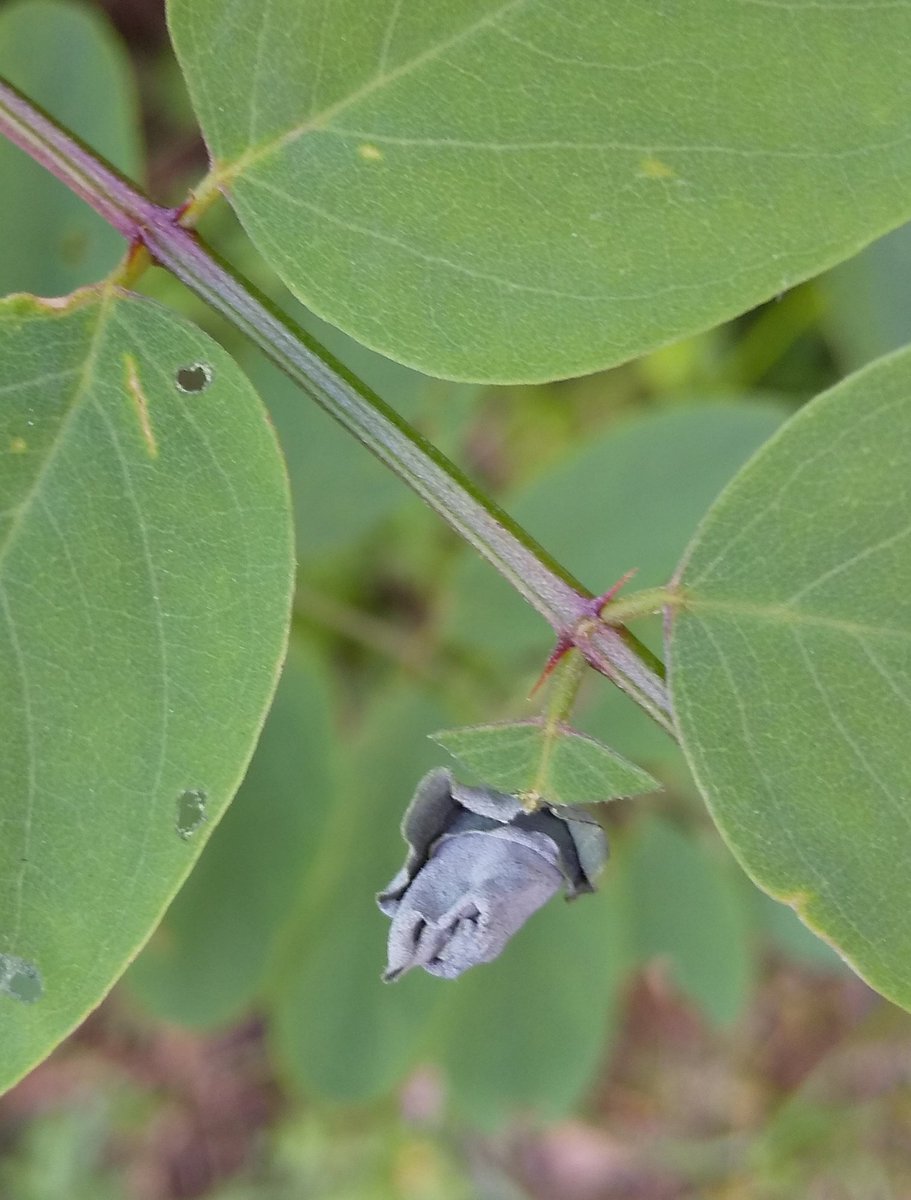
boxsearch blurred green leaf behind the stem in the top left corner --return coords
[0,0,140,296]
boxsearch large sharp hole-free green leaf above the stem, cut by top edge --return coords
[168,0,911,380]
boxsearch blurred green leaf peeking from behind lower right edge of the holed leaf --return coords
[127,647,335,1028]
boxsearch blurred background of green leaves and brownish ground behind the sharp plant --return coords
[0,0,911,1200]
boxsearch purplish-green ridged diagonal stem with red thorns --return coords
[0,80,672,732]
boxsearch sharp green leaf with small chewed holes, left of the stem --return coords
[0,290,292,1086]
